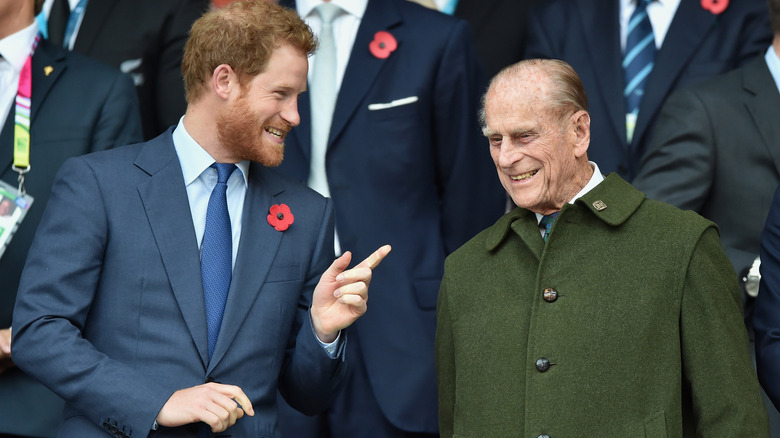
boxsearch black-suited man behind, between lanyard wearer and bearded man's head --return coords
[43,0,209,140]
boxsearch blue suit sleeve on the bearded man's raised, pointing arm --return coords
[279,199,347,415]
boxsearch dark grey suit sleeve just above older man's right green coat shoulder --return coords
[633,89,716,212]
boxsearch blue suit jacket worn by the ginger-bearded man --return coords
[13,131,345,438]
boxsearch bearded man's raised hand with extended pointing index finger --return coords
[311,245,391,342]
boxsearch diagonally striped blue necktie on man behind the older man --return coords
[623,0,656,134]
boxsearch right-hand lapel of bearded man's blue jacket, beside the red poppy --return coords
[207,163,284,373]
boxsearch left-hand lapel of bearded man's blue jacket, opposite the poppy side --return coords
[135,135,208,367]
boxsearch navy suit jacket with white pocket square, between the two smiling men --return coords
[280,0,506,432]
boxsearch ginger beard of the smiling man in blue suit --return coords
[217,95,292,167]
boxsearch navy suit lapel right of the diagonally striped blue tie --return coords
[631,0,717,148]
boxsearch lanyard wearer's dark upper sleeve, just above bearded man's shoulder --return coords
[90,72,143,152]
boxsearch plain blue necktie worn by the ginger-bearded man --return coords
[200,163,236,360]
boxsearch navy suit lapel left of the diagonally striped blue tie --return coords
[575,0,626,144]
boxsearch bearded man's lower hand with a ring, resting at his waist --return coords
[157,382,255,433]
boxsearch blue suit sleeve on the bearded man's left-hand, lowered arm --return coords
[12,158,171,436]
